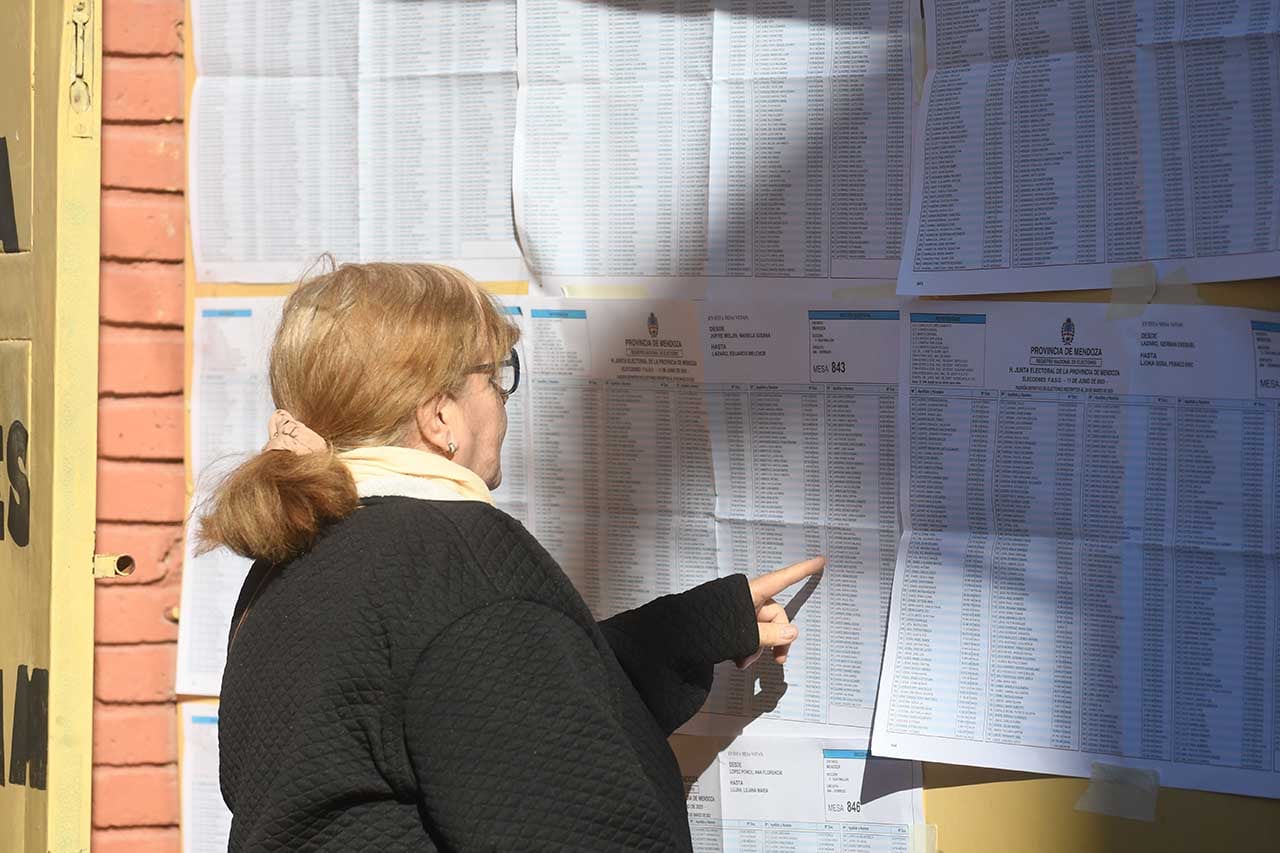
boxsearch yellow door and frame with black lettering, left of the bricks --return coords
[0,0,115,852]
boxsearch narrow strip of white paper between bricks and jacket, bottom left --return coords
[178,702,232,853]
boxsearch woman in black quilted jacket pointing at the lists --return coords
[202,264,822,850]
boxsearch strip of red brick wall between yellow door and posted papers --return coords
[92,0,186,853]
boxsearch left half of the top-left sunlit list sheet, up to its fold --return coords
[187,0,360,282]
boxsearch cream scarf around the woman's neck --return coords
[338,446,493,506]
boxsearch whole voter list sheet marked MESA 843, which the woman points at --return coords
[495,298,899,734]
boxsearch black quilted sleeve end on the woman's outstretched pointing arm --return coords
[600,575,760,734]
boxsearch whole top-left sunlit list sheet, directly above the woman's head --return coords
[188,0,526,283]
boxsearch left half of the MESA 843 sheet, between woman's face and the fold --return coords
[494,300,717,607]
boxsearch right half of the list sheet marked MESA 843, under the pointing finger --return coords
[694,302,900,733]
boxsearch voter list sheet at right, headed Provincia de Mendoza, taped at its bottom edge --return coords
[872,302,1280,797]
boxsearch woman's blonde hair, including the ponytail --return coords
[198,264,518,562]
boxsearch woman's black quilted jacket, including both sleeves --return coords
[219,497,758,850]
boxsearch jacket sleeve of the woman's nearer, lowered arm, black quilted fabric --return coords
[404,601,684,850]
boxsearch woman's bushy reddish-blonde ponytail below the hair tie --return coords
[198,450,360,564]
